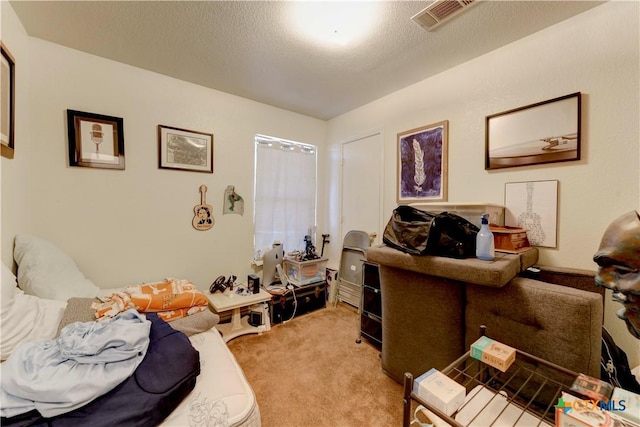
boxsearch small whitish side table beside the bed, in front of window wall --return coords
[207,289,271,342]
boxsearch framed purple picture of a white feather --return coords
[397,120,449,204]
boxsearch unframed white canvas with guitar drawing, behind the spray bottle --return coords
[504,180,558,248]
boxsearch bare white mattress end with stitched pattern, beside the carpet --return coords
[162,328,260,427]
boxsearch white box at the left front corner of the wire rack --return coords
[413,368,467,416]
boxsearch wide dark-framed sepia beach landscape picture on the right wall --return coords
[485,92,581,169]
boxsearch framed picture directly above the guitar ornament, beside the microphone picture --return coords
[158,125,213,173]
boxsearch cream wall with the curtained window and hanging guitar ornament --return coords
[2,2,327,289]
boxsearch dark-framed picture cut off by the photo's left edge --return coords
[0,42,16,159]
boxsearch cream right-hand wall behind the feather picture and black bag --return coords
[326,2,640,365]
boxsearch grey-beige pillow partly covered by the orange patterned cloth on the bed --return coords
[56,298,220,336]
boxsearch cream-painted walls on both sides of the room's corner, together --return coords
[1,1,640,364]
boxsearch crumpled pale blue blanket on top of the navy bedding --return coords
[0,310,151,417]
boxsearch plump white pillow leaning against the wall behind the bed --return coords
[13,234,100,302]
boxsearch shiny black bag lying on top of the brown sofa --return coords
[382,205,479,258]
